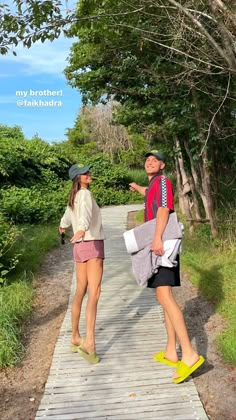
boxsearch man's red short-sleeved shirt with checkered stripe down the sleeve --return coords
[144,174,174,222]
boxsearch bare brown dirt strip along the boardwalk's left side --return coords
[0,244,73,420]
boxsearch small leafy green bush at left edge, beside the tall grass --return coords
[0,213,21,285]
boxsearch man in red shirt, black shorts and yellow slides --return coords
[130,150,204,383]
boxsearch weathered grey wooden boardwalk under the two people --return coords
[36,205,208,420]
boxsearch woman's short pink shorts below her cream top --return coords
[73,240,105,262]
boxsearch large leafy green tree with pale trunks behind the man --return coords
[62,1,235,235]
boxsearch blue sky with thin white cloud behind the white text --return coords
[0,2,81,143]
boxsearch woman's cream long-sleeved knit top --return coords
[60,188,104,242]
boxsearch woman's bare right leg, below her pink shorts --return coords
[83,258,103,353]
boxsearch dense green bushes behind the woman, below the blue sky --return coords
[0,126,145,228]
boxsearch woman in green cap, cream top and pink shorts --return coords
[59,164,104,364]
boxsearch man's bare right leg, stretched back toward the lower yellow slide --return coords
[156,286,199,366]
